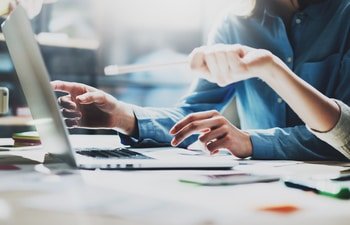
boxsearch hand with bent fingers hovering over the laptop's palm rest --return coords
[170,111,252,158]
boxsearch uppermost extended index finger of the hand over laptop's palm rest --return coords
[171,118,226,146]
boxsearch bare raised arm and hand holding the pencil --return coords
[191,45,340,132]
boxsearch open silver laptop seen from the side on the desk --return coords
[2,6,237,169]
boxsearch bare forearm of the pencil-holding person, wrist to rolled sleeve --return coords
[261,57,340,132]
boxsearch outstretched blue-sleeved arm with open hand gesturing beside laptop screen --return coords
[51,80,234,147]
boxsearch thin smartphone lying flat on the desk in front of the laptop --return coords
[180,173,280,186]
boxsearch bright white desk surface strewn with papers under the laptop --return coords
[0,136,350,225]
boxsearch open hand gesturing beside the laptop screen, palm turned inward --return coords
[51,81,136,135]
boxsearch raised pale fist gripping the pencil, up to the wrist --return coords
[190,44,277,87]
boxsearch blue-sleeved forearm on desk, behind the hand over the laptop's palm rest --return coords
[248,126,346,161]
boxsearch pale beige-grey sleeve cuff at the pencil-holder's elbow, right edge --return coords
[306,99,350,159]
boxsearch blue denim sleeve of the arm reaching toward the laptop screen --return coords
[120,79,235,148]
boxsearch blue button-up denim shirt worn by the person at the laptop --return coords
[121,0,350,160]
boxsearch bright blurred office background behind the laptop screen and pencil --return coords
[0,0,238,137]
